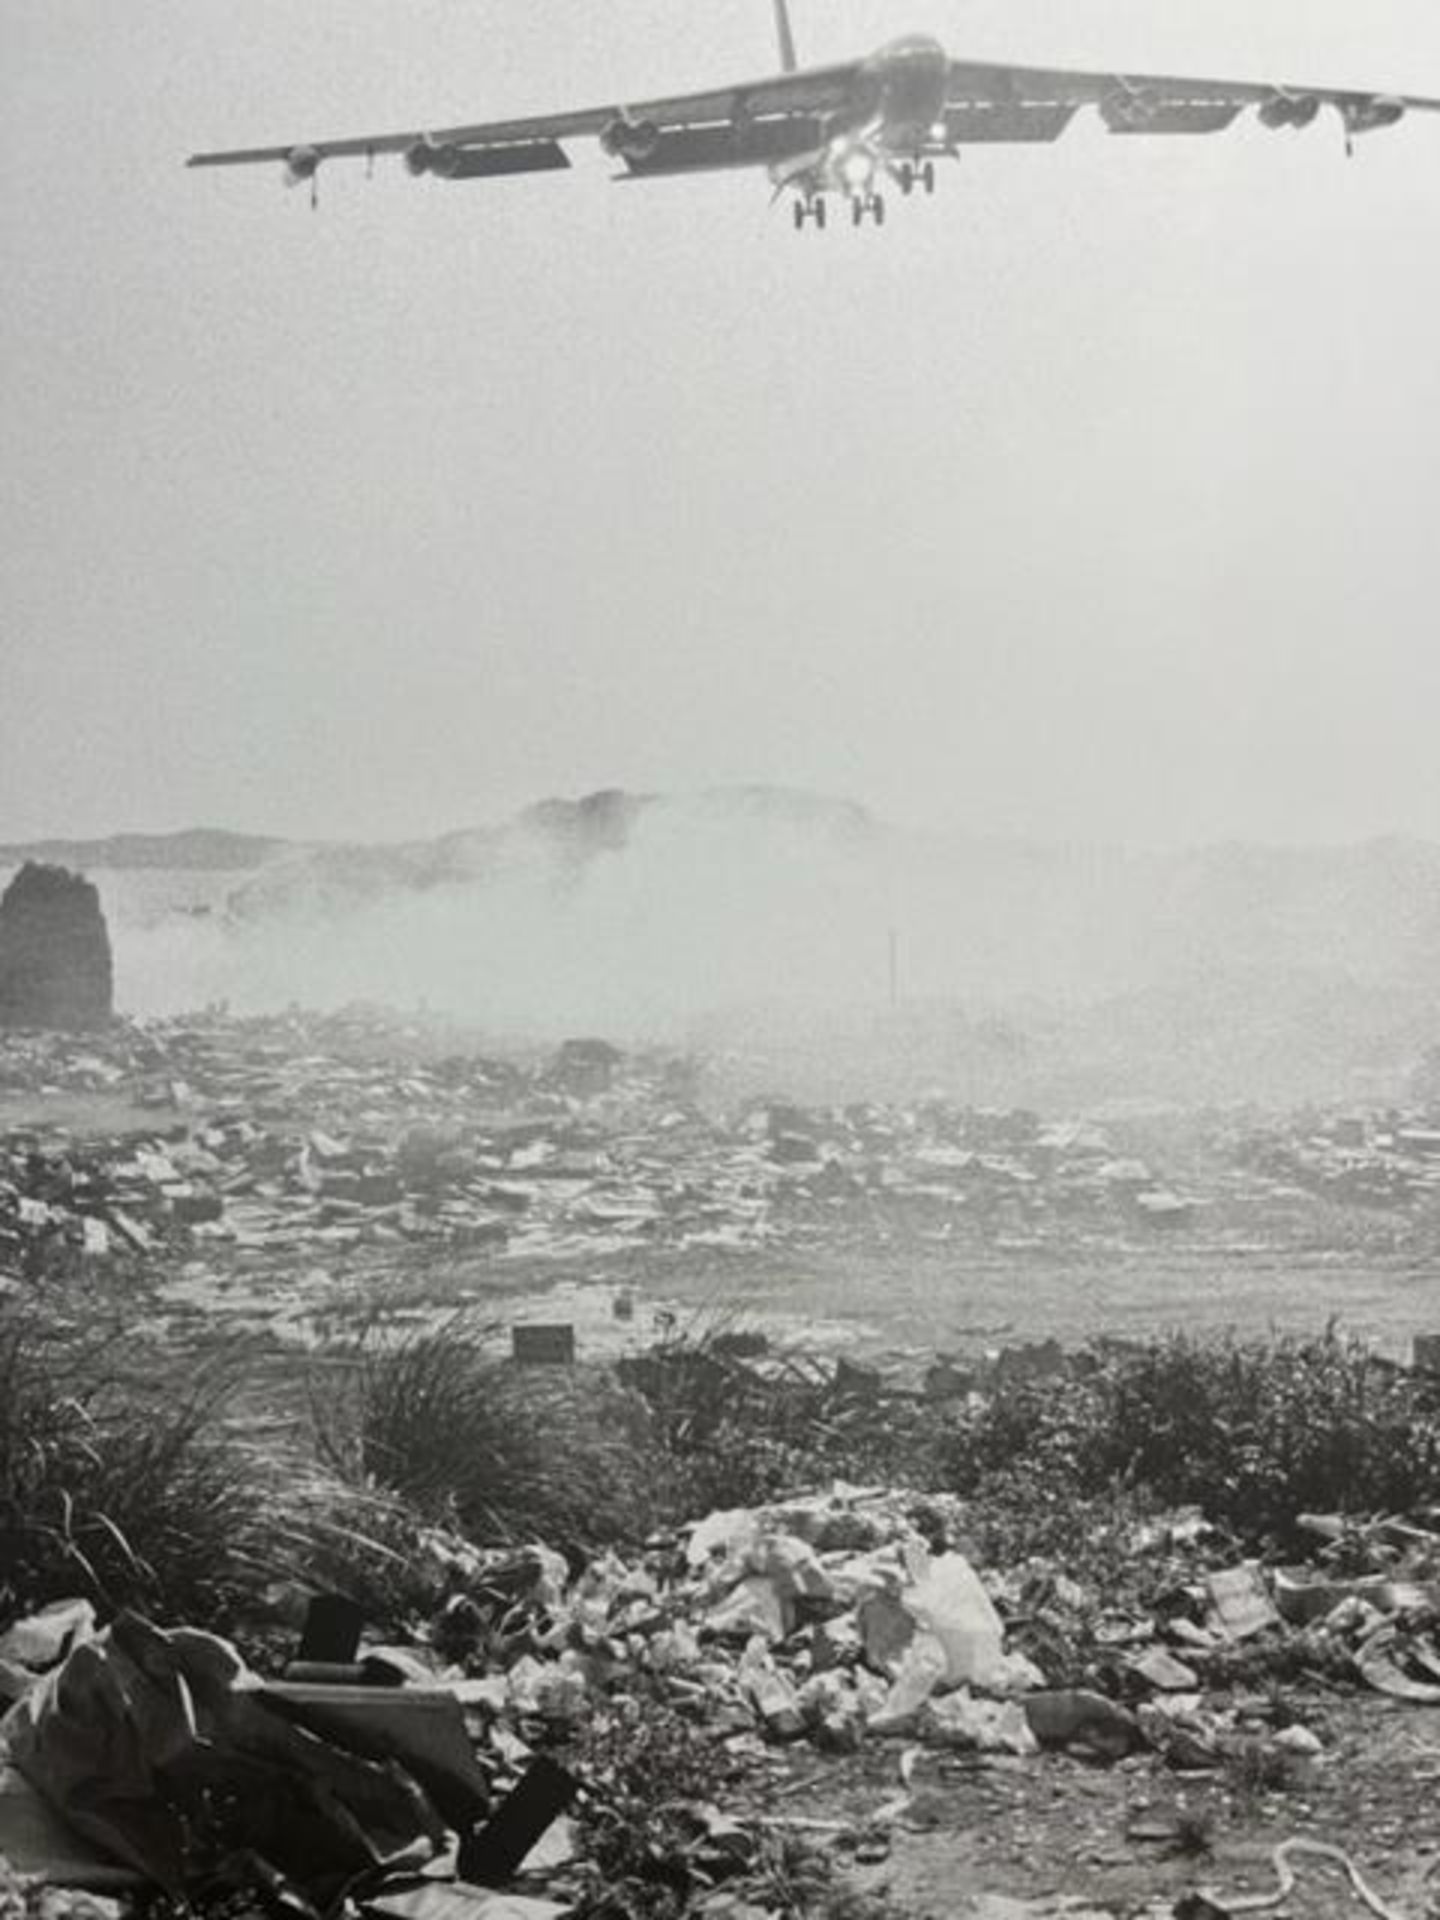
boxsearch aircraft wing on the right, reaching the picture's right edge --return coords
[945,60,1440,144]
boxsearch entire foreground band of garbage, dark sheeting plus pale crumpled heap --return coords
[0,1484,1440,1920]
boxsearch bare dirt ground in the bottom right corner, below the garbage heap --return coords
[770,1693,1440,1920]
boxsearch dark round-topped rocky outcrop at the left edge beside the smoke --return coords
[0,860,115,1031]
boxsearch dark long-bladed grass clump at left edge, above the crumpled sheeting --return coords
[0,1309,422,1630]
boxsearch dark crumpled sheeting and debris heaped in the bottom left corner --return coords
[0,1607,574,1920]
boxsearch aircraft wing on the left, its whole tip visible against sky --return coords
[188,61,858,179]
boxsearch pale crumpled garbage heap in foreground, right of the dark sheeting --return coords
[401,1486,1440,1768]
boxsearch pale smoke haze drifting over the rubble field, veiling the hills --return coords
[10,789,1440,1102]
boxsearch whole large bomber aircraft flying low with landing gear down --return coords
[188,0,1440,230]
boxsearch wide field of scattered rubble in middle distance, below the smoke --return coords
[14,1008,1440,1351]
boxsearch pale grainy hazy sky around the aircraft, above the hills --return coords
[0,0,1440,841]
